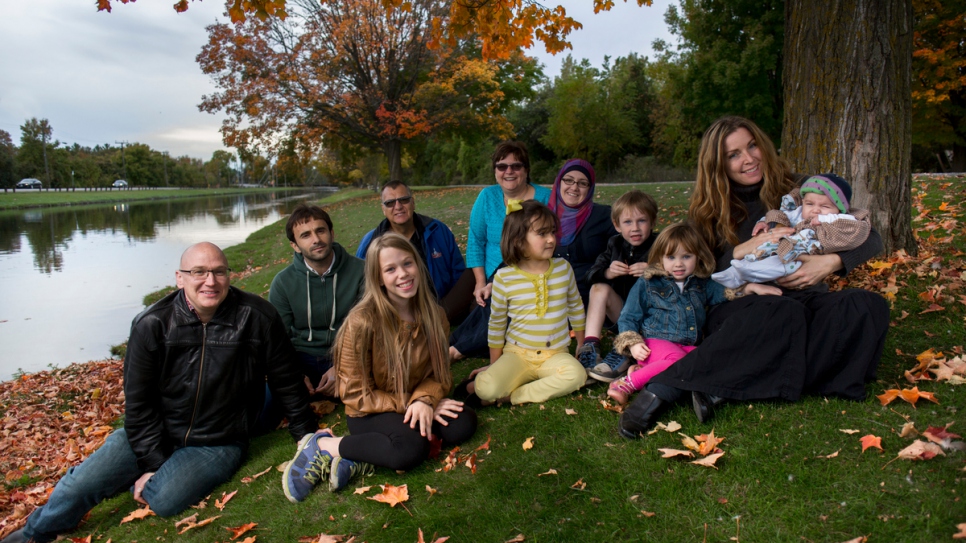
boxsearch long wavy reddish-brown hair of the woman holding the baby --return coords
[688,116,795,251]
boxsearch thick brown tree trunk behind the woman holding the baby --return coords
[782,0,916,254]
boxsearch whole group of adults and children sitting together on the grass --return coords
[2,117,889,543]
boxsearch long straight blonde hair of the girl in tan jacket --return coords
[332,232,453,401]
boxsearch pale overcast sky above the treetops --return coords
[0,0,672,160]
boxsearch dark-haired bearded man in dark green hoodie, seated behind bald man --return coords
[268,204,365,397]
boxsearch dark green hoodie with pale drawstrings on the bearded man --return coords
[268,242,365,356]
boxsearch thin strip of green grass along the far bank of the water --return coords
[0,187,320,210]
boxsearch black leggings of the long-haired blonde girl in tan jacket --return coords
[339,405,476,471]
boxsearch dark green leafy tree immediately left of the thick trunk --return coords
[652,0,785,165]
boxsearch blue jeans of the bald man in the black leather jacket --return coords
[24,428,244,543]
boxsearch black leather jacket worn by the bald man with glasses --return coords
[124,287,317,472]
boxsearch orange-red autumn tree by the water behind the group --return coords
[197,0,512,179]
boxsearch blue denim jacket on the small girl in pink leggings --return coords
[615,268,735,347]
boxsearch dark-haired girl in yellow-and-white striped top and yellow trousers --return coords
[474,200,587,404]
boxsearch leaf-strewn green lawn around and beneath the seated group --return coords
[74,179,966,543]
